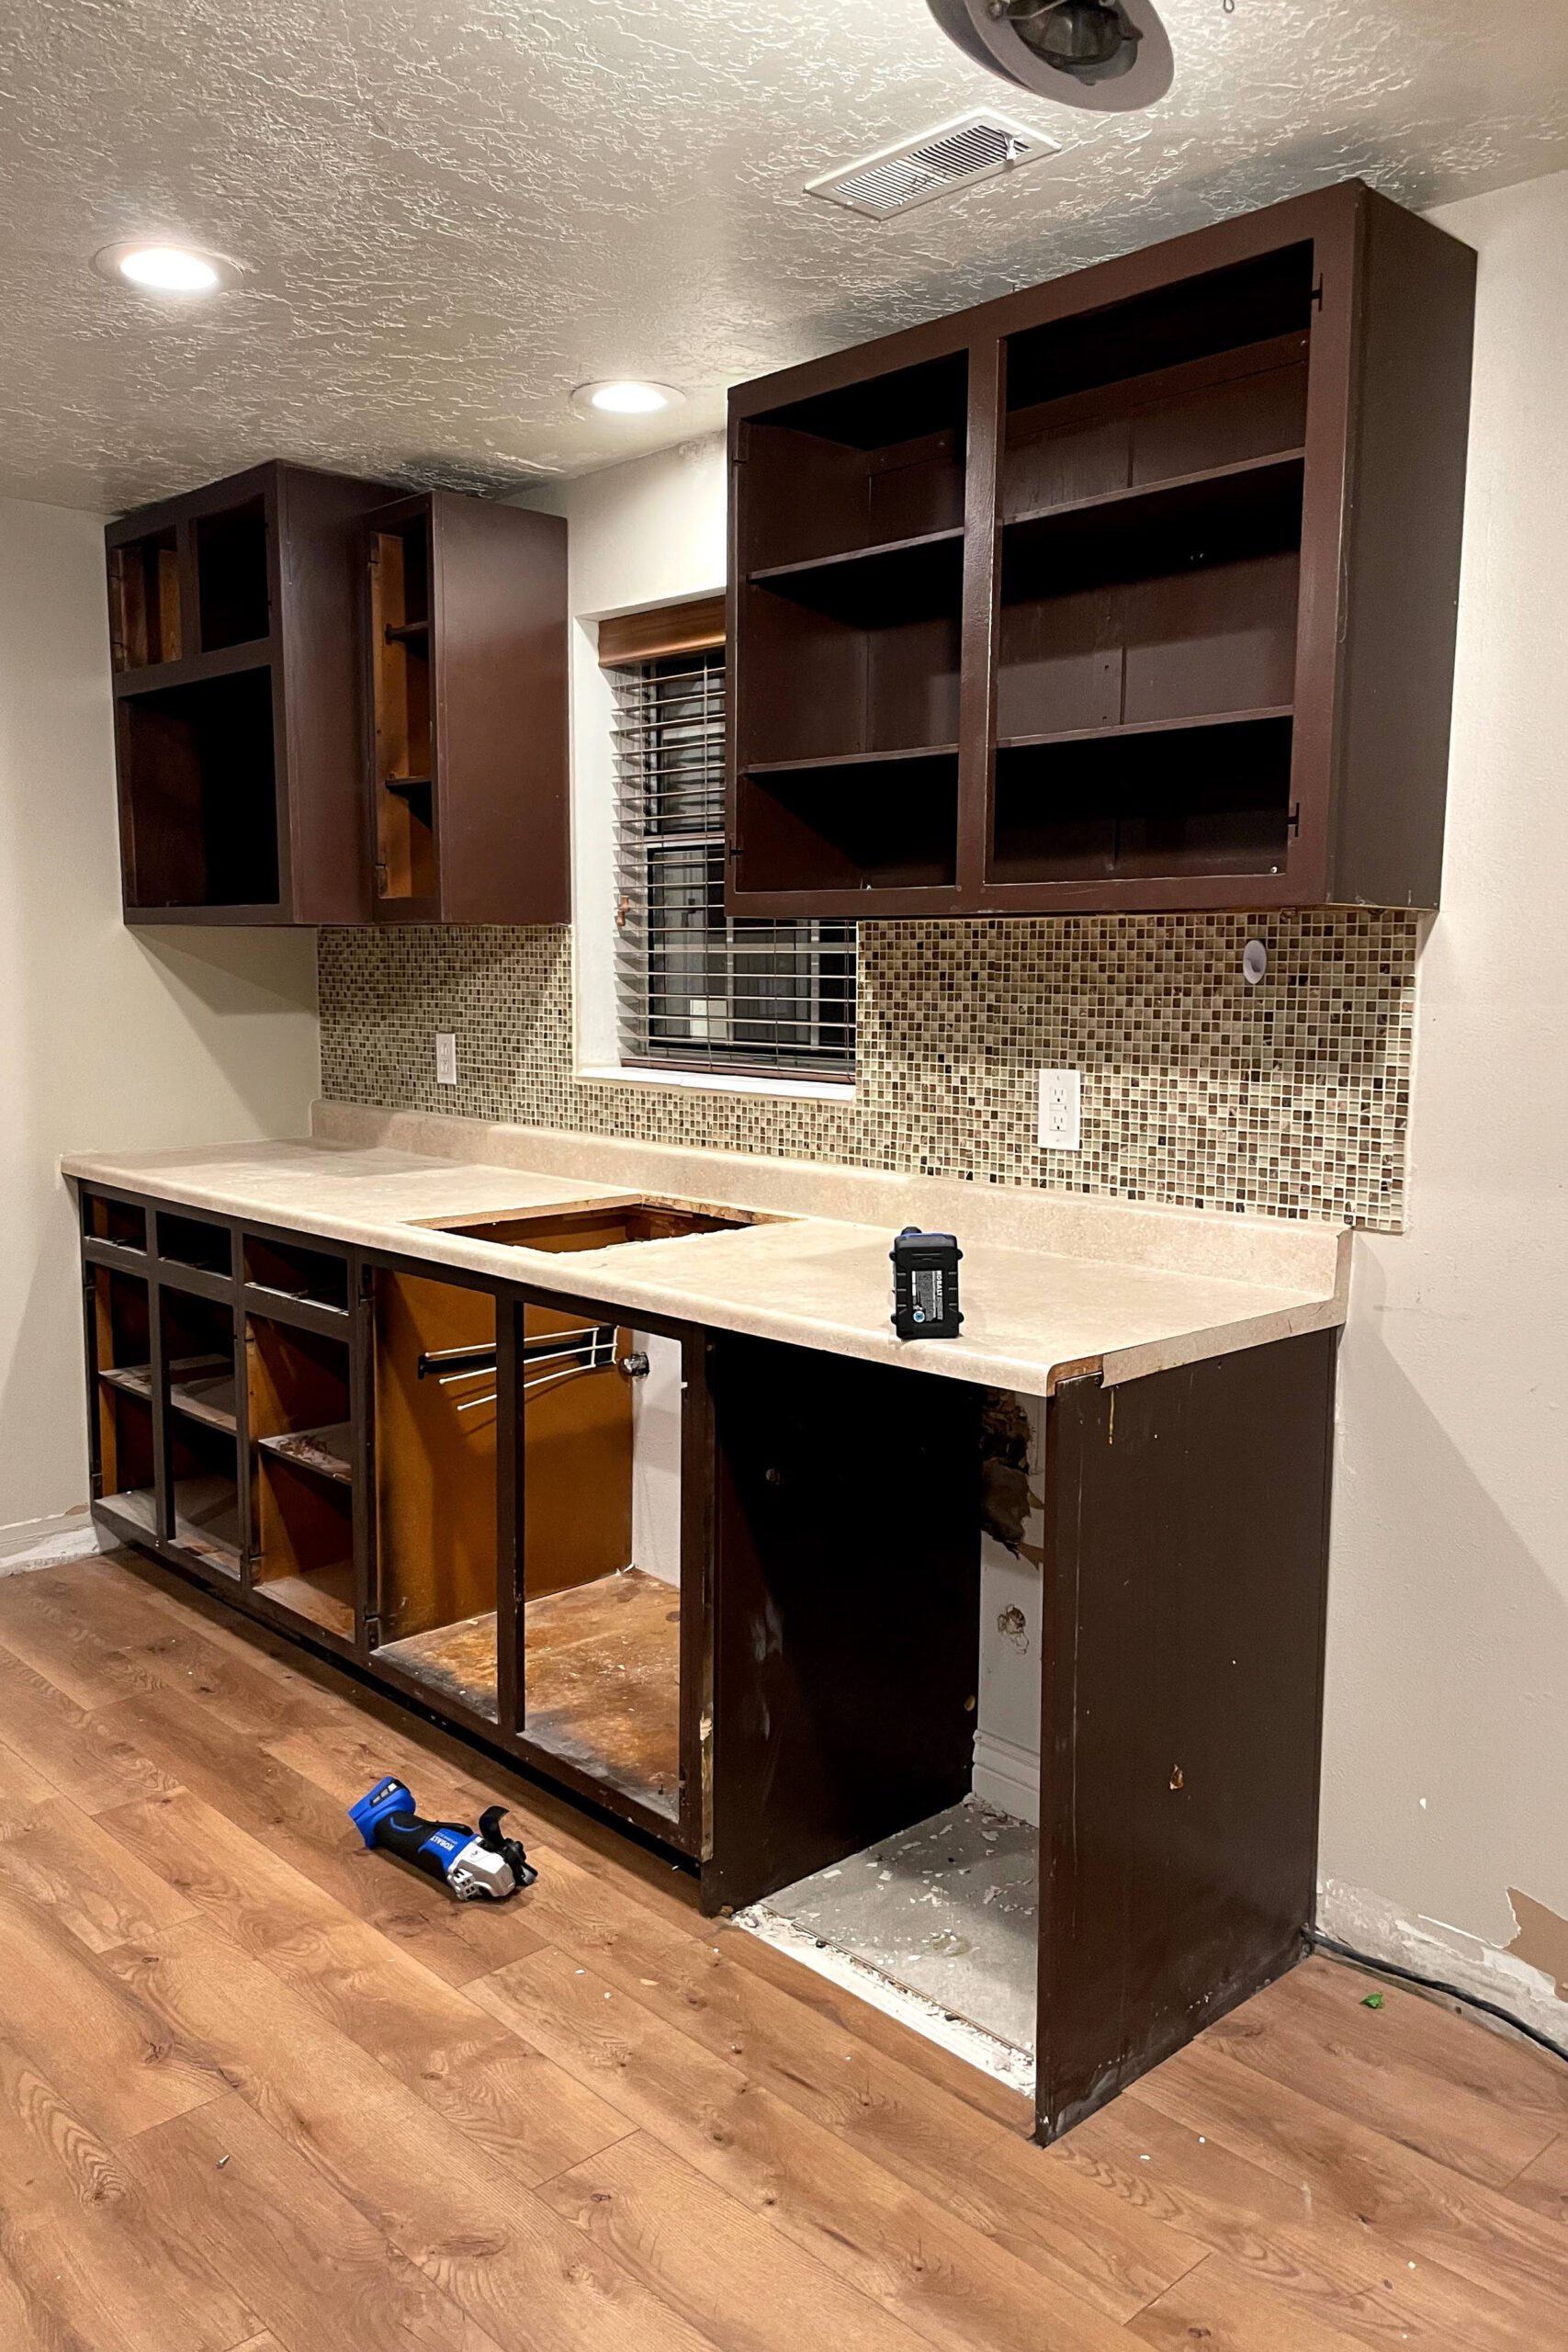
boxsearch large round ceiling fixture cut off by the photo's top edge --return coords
[926,0,1176,113]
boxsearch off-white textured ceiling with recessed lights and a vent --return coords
[0,0,1568,508]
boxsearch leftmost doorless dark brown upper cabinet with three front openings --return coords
[106,463,386,924]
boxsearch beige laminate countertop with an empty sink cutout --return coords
[62,1105,1349,1395]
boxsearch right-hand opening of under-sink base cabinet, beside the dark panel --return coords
[520,1303,682,1820]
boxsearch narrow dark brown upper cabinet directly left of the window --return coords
[362,489,571,924]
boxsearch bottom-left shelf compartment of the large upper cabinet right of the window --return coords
[736,752,959,891]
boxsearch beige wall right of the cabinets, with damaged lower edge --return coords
[1321,174,1568,2037]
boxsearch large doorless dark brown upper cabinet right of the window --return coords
[727,181,1474,917]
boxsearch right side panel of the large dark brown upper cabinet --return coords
[1328,195,1476,906]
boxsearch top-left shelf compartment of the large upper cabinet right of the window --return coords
[740,350,968,574]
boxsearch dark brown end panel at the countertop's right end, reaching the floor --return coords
[1037,1331,1336,2141]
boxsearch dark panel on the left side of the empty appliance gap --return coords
[703,1336,980,1910]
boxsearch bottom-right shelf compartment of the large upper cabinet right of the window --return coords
[989,718,1291,882]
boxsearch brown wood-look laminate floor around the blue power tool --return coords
[0,1559,1568,2352]
